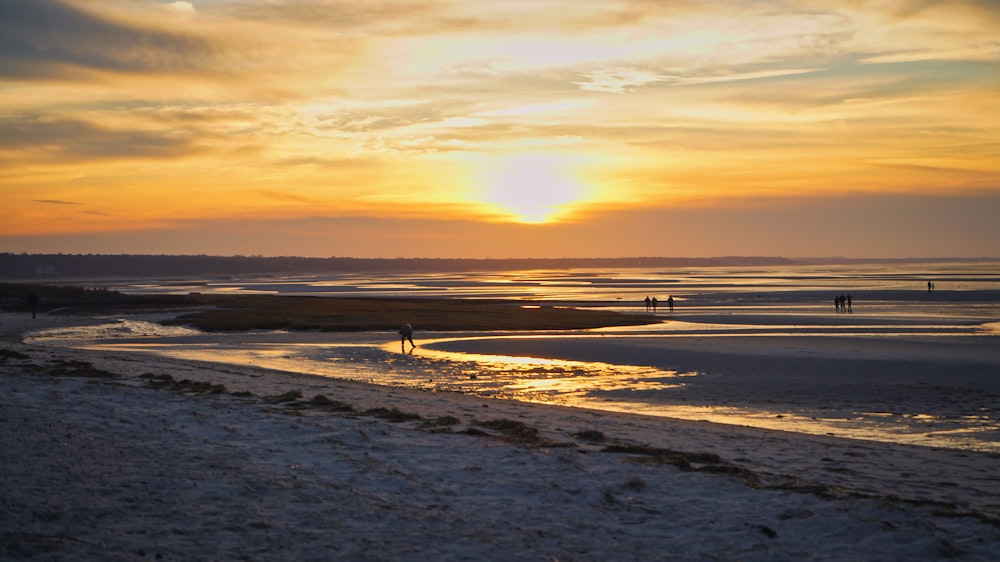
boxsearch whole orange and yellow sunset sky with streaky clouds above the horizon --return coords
[0,0,1000,258]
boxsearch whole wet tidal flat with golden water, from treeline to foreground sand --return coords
[29,263,1000,452]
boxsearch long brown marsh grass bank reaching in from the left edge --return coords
[0,284,657,332]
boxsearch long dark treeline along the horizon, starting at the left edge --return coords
[0,253,795,280]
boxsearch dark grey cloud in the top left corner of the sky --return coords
[0,0,216,79]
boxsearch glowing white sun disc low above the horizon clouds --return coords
[483,153,587,224]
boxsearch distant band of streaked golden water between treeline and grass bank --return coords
[76,262,1000,300]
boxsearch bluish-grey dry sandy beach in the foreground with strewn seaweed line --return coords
[0,314,1000,560]
